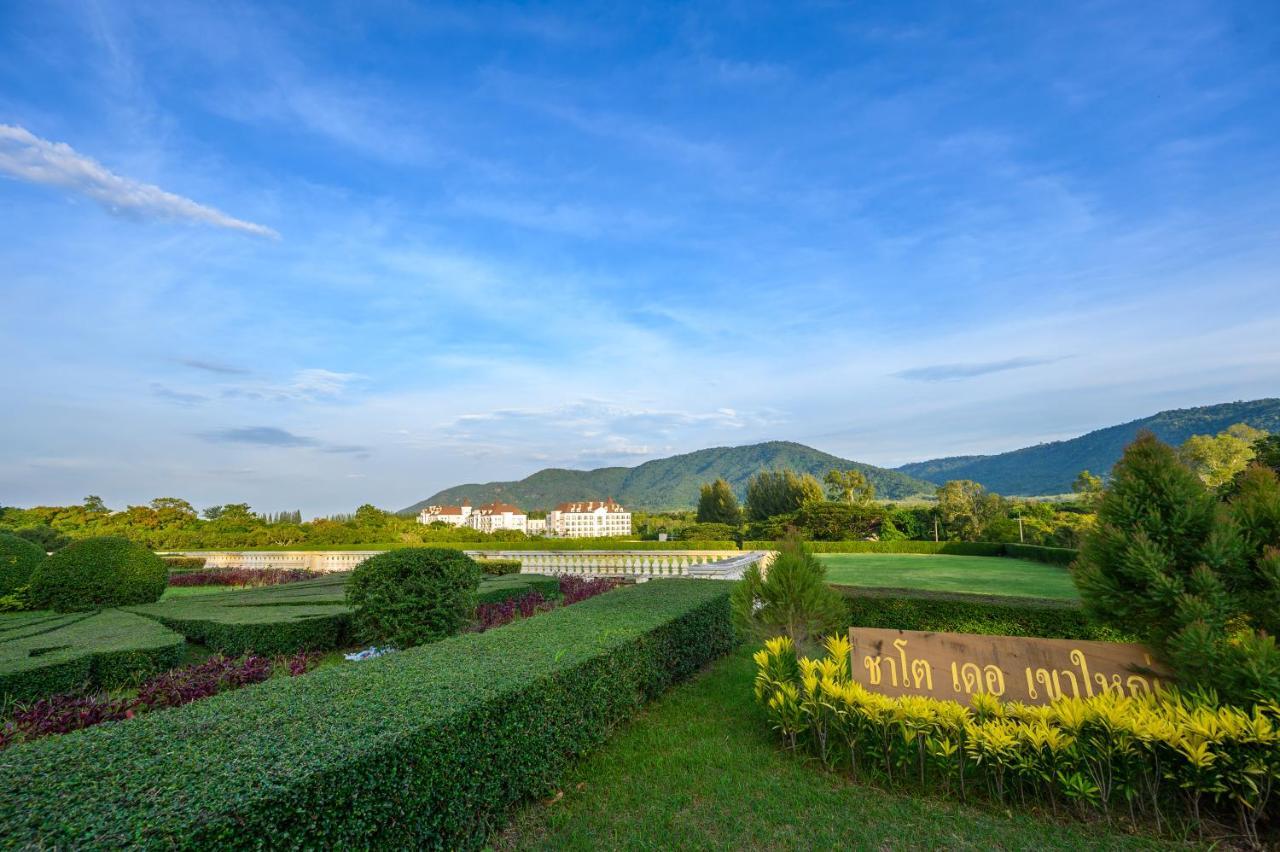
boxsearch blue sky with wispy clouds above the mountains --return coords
[0,0,1280,514]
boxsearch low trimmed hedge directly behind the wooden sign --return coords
[835,586,1137,642]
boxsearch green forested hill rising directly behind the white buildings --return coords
[401,441,933,514]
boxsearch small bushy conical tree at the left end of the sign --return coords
[731,536,847,649]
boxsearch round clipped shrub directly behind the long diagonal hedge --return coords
[347,548,480,649]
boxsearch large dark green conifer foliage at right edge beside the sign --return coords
[1075,434,1280,702]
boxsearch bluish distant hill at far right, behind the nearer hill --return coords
[897,399,1280,495]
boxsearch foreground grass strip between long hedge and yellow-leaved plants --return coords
[490,647,1169,849]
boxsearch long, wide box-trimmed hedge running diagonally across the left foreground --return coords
[0,580,733,848]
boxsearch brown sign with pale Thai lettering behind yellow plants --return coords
[849,627,1172,704]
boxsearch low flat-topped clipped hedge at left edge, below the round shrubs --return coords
[0,609,186,705]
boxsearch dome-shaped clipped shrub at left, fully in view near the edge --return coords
[31,536,169,613]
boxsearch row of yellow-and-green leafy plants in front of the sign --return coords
[755,636,1280,846]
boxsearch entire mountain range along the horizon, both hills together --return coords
[401,399,1280,514]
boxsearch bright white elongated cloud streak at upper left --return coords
[0,124,280,239]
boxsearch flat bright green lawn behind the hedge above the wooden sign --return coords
[818,553,1079,600]
